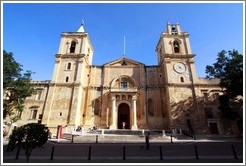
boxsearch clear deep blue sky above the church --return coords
[1,2,244,80]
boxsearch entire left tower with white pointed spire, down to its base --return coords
[43,24,93,131]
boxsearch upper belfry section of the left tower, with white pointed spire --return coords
[52,21,93,83]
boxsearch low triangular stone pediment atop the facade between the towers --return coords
[104,57,144,67]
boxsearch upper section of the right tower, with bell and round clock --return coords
[156,23,196,84]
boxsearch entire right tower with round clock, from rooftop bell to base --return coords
[156,23,201,130]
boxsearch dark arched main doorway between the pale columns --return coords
[118,103,130,129]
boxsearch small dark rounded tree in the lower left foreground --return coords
[8,123,49,162]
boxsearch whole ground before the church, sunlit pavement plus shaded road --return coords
[3,134,244,164]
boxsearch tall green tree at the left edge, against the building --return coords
[3,50,35,124]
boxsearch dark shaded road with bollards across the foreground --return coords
[2,141,244,164]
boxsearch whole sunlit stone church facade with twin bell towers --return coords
[18,23,223,134]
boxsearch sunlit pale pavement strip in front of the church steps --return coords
[49,134,242,143]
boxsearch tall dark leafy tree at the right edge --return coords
[206,50,243,134]
